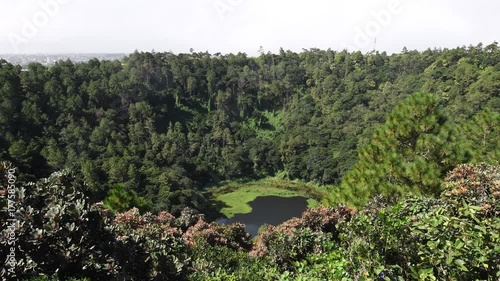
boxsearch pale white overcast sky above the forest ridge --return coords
[0,0,500,55]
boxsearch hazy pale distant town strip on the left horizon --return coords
[0,53,127,68]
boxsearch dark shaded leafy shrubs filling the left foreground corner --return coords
[0,162,193,280]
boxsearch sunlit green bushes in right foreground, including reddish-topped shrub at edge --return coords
[341,165,500,280]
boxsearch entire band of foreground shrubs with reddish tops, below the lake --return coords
[0,163,500,281]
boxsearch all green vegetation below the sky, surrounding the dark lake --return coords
[0,43,500,281]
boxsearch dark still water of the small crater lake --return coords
[218,196,307,236]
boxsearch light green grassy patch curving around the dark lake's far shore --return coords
[210,178,323,218]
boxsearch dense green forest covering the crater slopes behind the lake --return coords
[0,42,500,211]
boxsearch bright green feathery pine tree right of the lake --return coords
[340,93,465,207]
